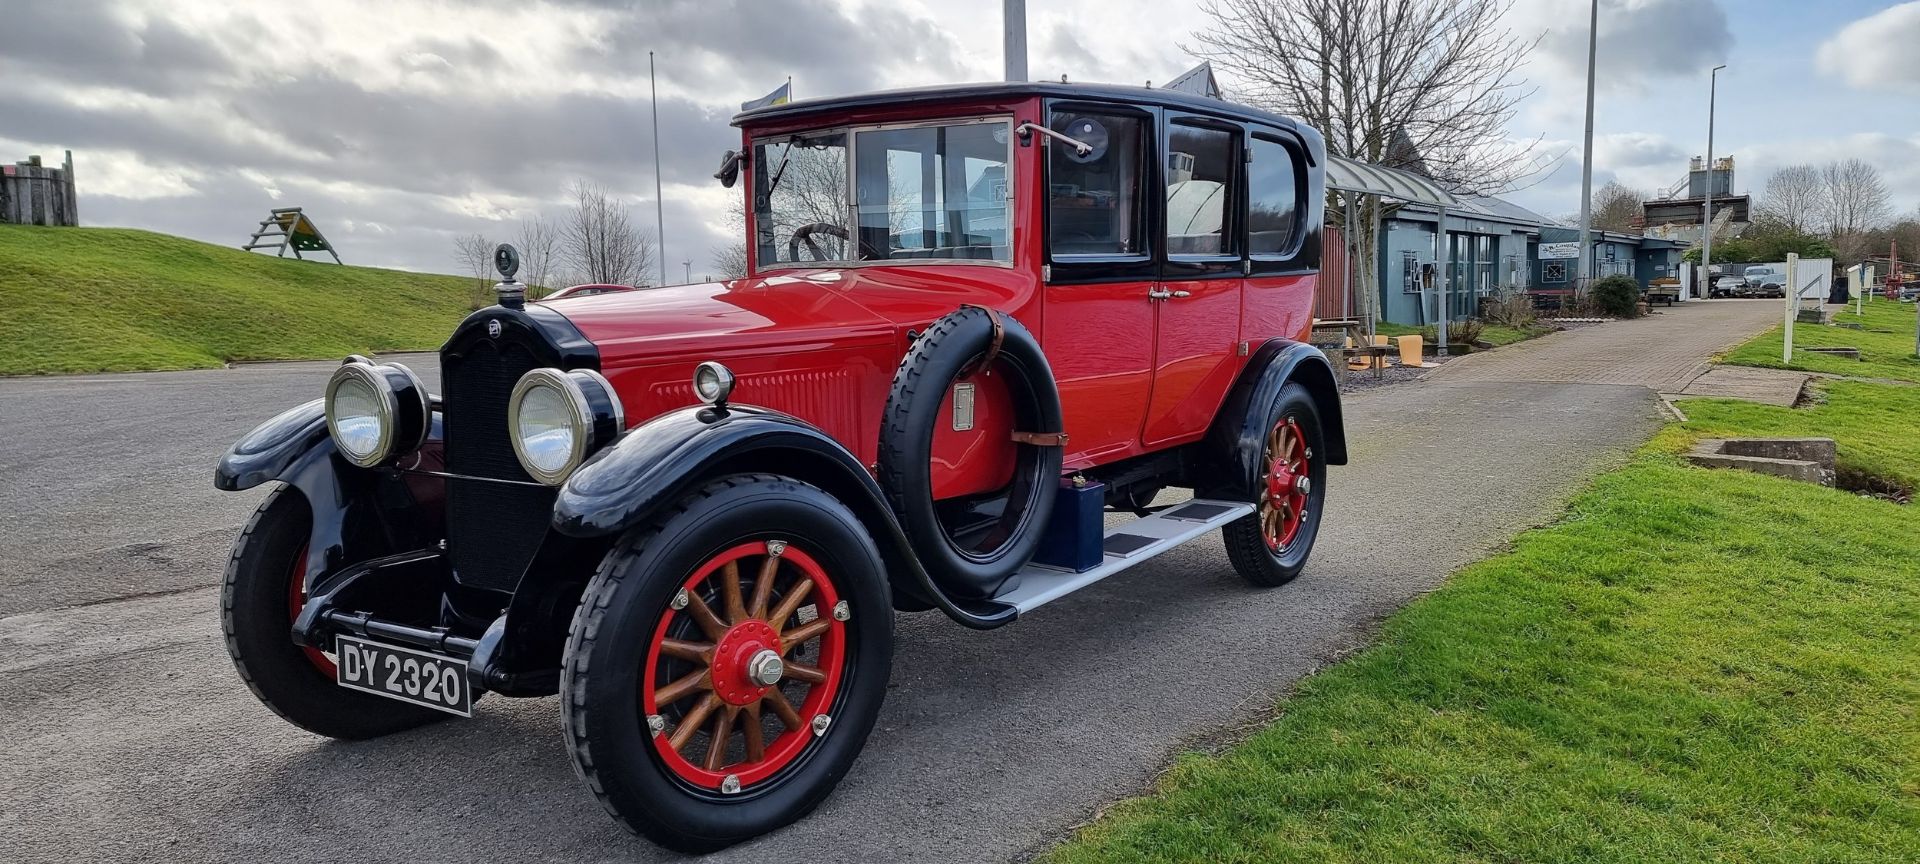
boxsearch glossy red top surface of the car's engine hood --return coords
[545,273,895,369]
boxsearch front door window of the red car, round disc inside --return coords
[1046,111,1148,255]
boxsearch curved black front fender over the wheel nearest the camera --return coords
[553,405,1014,630]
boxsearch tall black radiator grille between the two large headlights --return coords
[442,336,557,591]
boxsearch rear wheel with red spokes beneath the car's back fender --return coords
[1221,382,1327,588]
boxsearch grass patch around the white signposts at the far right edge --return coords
[1720,298,1920,382]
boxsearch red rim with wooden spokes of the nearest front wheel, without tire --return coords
[639,540,847,793]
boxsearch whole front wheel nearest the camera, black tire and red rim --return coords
[561,474,893,852]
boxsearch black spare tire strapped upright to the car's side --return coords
[879,305,1066,599]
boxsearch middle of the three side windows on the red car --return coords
[1167,123,1240,255]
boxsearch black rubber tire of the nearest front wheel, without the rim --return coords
[561,474,893,854]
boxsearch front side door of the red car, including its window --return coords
[1041,100,1160,468]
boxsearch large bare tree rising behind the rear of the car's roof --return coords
[1194,0,1542,194]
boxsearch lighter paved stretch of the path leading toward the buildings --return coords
[1427,300,1780,394]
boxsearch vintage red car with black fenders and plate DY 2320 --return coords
[217,83,1346,851]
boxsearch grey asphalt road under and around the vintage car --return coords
[0,301,1776,862]
